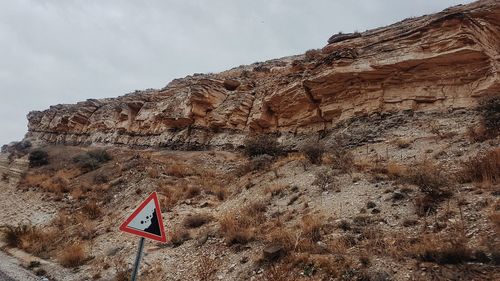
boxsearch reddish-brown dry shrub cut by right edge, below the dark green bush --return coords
[458,148,500,183]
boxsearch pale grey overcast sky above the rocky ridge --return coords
[0,0,471,144]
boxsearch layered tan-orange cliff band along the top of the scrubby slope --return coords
[27,0,500,147]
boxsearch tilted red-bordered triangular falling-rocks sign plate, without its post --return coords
[120,192,167,243]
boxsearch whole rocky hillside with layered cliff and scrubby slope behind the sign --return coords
[0,0,500,281]
